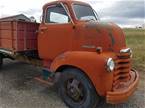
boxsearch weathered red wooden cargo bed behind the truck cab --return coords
[0,21,39,52]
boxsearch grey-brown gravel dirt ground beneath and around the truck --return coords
[0,60,145,108]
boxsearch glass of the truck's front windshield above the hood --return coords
[73,4,97,21]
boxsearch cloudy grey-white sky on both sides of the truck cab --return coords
[0,0,145,27]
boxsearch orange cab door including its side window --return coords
[38,3,74,60]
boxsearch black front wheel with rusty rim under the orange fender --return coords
[58,68,100,108]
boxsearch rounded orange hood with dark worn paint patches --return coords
[76,21,126,52]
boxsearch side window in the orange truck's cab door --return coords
[45,5,70,24]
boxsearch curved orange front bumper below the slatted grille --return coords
[106,70,139,104]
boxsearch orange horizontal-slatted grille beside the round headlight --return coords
[113,51,131,90]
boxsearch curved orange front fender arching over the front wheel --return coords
[50,51,113,96]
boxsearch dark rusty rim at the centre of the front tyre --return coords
[65,78,86,103]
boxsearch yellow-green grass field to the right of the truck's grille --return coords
[124,29,145,74]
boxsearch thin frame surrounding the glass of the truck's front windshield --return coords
[71,3,99,21]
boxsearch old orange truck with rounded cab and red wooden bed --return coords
[0,0,139,108]
